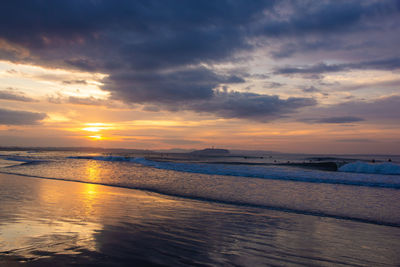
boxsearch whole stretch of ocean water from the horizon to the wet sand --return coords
[0,151,400,226]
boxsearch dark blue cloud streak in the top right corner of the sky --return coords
[260,1,400,36]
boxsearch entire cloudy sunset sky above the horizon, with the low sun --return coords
[0,0,400,154]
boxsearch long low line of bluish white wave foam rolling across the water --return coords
[69,156,400,189]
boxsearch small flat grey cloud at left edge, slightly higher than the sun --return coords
[0,109,46,125]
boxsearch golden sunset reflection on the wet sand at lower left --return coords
[0,173,181,265]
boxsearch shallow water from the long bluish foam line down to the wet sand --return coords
[0,154,400,226]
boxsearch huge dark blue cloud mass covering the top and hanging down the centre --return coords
[0,0,399,121]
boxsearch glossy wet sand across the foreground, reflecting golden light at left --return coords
[0,174,400,266]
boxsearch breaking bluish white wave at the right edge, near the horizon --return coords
[338,161,400,175]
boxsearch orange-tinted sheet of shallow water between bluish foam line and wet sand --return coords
[4,159,400,226]
